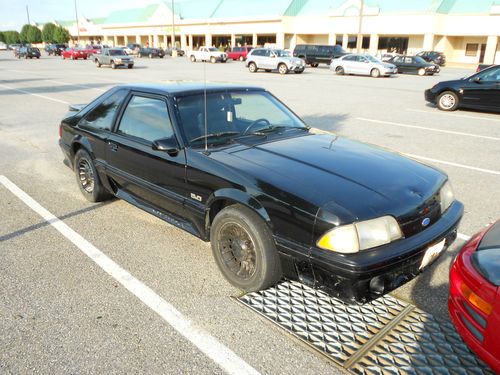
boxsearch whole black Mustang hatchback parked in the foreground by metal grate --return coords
[60,83,463,303]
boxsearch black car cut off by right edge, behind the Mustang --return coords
[425,65,500,112]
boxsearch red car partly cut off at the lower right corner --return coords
[448,220,500,374]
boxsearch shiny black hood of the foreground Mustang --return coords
[213,134,446,220]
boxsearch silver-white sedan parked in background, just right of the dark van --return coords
[330,54,398,78]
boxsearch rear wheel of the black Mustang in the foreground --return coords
[73,149,111,202]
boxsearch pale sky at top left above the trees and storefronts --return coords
[0,0,161,31]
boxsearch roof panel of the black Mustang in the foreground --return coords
[117,81,265,96]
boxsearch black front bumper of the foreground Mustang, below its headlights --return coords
[278,201,464,303]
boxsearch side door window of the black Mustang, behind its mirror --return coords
[117,95,174,142]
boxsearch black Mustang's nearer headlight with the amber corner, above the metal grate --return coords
[316,216,403,254]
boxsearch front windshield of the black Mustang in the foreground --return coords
[177,91,308,147]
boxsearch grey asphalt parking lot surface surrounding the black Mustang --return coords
[0,51,500,374]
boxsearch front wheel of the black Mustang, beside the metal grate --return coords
[210,205,282,292]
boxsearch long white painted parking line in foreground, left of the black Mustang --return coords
[0,176,259,375]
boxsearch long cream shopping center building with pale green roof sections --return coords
[50,0,500,64]
